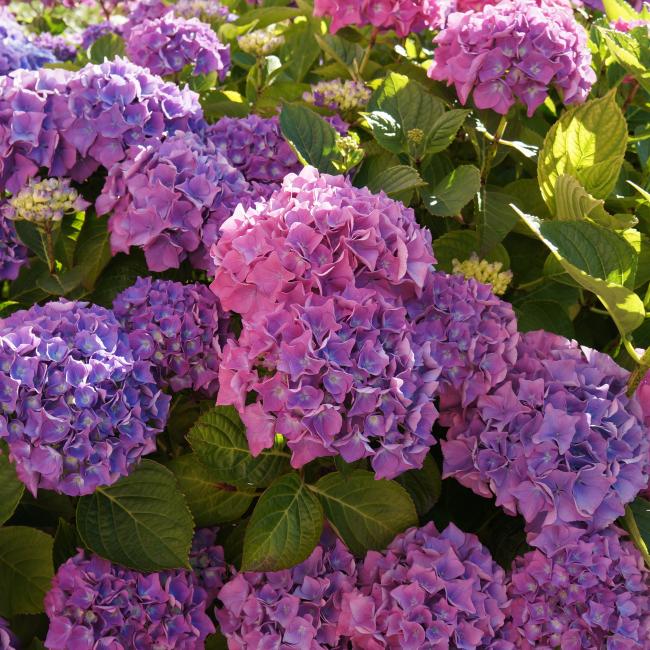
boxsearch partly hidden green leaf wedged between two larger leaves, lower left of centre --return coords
[167,454,256,526]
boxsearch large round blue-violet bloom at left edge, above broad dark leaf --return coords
[0,299,170,496]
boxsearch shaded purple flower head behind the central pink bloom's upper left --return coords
[206,114,302,199]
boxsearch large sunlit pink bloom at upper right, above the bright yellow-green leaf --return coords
[428,0,596,117]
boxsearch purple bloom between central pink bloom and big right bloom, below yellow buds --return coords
[415,272,518,426]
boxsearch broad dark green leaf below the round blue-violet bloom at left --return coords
[77,460,193,572]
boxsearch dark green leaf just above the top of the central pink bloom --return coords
[280,104,336,174]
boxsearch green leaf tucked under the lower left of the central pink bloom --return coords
[187,406,291,488]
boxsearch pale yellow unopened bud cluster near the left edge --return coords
[3,178,89,224]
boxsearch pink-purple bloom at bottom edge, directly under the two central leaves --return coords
[215,534,356,650]
